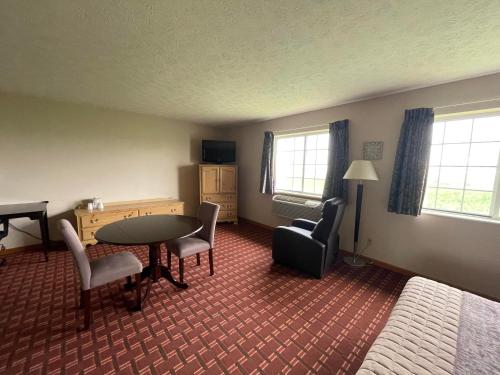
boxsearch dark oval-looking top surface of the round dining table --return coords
[95,215,203,246]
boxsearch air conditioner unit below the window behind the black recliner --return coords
[272,195,323,221]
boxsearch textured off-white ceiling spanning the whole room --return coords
[0,0,500,124]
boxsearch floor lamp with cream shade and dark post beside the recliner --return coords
[344,160,378,267]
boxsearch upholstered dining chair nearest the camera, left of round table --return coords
[58,219,142,329]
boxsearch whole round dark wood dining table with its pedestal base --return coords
[95,215,203,289]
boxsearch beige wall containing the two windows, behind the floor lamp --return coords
[228,75,500,297]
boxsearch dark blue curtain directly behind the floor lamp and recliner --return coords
[322,120,349,202]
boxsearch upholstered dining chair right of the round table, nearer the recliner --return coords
[167,202,220,283]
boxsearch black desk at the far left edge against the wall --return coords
[0,201,50,261]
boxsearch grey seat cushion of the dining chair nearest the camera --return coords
[90,251,142,288]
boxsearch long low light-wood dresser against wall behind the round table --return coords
[74,198,184,245]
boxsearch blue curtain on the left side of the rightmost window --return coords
[388,108,434,216]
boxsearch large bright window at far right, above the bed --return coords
[423,113,500,219]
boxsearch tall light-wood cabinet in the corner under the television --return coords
[200,164,238,223]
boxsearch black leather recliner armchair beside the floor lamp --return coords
[273,198,345,278]
